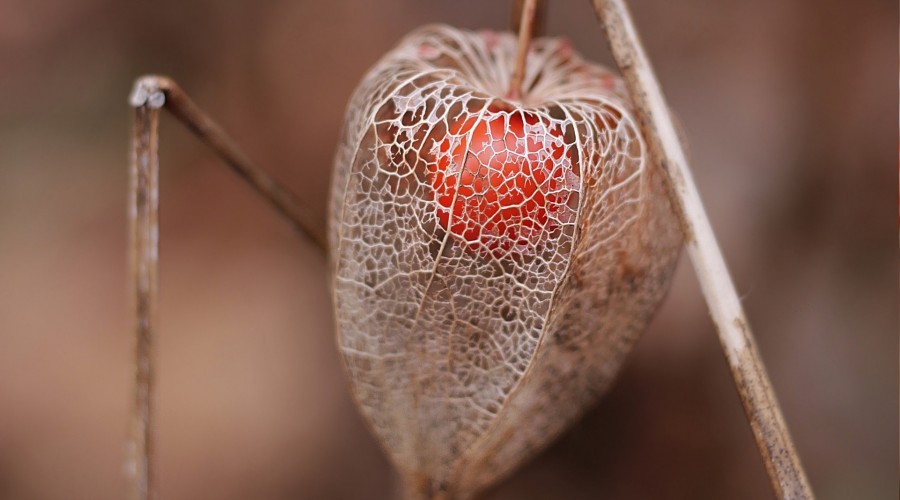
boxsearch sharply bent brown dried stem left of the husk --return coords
[126,76,325,500]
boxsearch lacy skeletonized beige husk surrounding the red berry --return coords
[329,26,681,498]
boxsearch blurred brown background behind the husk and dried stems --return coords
[0,0,898,500]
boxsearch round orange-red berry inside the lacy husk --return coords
[429,106,577,257]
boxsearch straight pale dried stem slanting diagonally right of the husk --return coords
[593,0,813,499]
